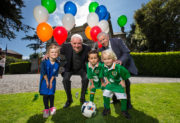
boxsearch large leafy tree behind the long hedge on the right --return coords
[133,0,180,51]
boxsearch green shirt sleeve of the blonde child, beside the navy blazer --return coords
[119,65,131,80]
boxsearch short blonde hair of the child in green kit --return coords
[101,49,117,60]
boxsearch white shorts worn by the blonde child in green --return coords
[103,89,127,99]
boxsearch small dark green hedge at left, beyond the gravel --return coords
[9,61,31,74]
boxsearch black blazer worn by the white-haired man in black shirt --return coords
[60,43,91,72]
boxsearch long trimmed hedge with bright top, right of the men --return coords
[131,51,180,77]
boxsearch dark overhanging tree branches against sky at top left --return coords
[0,0,30,40]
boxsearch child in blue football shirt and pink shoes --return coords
[39,44,59,118]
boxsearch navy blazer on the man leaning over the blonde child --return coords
[99,38,138,75]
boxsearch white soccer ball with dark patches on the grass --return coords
[81,102,96,118]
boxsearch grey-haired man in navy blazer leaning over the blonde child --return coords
[97,32,138,109]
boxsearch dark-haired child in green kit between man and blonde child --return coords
[87,50,104,102]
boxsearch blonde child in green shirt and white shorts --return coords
[101,50,130,119]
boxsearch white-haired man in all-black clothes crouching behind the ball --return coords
[60,34,91,108]
